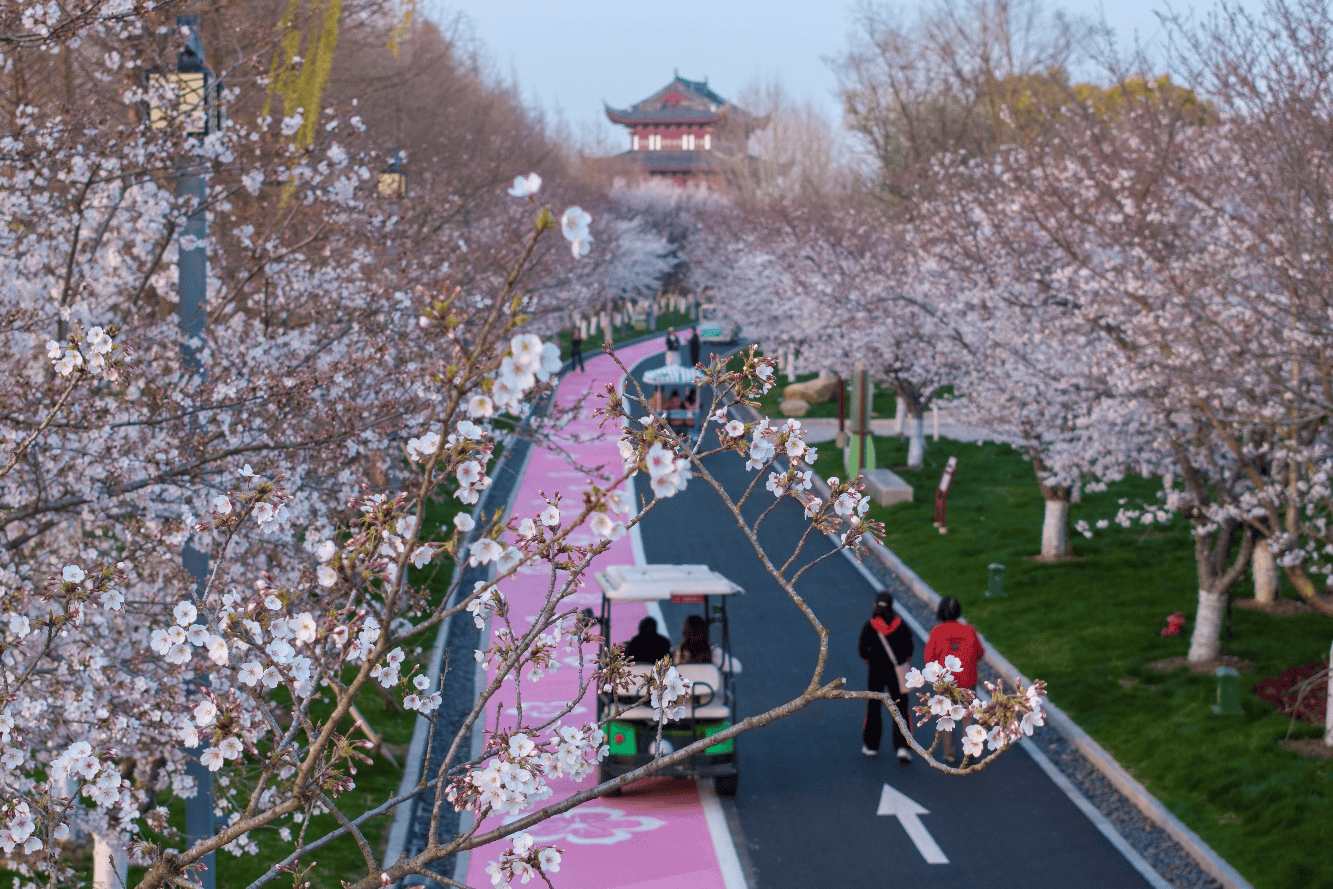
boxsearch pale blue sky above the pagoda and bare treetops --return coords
[427,0,1260,151]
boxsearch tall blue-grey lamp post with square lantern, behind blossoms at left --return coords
[149,16,221,889]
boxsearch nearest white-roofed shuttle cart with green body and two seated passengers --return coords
[593,565,744,796]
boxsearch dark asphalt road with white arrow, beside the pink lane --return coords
[626,360,1148,889]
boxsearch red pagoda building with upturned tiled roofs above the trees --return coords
[607,72,768,185]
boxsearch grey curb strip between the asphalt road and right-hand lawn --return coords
[733,405,1254,889]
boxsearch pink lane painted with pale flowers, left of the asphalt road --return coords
[468,339,744,889]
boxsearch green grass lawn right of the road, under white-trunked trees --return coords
[817,437,1333,889]
